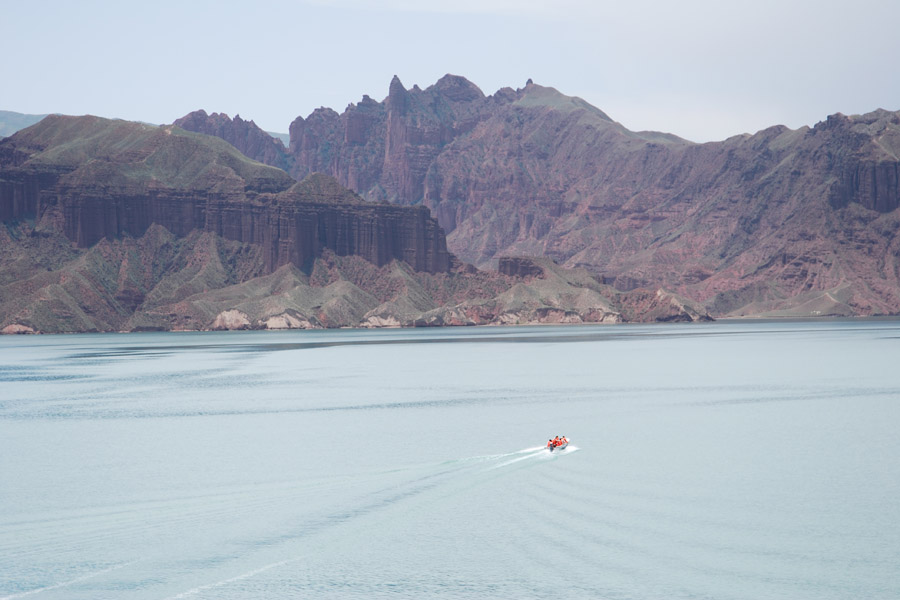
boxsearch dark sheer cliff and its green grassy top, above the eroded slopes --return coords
[0,117,451,272]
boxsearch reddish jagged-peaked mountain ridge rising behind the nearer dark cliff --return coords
[176,75,900,316]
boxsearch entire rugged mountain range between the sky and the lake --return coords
[0,75,900,331]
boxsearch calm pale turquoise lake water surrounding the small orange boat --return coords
[0,321,900,600]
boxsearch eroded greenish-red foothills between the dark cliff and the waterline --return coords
[0,222,702,334]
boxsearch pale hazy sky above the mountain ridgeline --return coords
[0,0,900,141]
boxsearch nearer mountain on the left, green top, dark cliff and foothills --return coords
[0,115,708,333]
